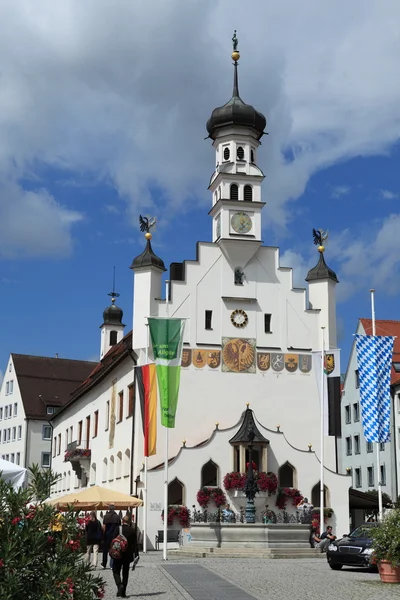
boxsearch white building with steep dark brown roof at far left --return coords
[0,354,96,468]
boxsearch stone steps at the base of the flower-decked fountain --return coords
[168,546,326,559]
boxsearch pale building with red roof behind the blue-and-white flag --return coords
[340,319,400,499]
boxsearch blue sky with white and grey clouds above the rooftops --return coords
[0,0,400,380]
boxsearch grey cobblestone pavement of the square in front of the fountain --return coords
[99,552,400,600]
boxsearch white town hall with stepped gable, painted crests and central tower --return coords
[52,39,351,547]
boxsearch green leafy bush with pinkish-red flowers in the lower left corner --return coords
[0,467,104,600]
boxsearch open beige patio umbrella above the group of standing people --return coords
[47,485,143,510]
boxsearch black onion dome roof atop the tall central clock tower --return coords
[206,61,267,139]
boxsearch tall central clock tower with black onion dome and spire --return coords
[206,31,267,271]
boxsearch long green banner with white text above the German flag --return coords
[148,318,185,428]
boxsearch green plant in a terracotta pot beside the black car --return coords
[371,508,400,583]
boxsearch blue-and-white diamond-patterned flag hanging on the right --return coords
[355,335,394,442]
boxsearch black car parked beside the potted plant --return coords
[326,523,379,570]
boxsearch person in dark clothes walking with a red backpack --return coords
[110,515,139,598]
